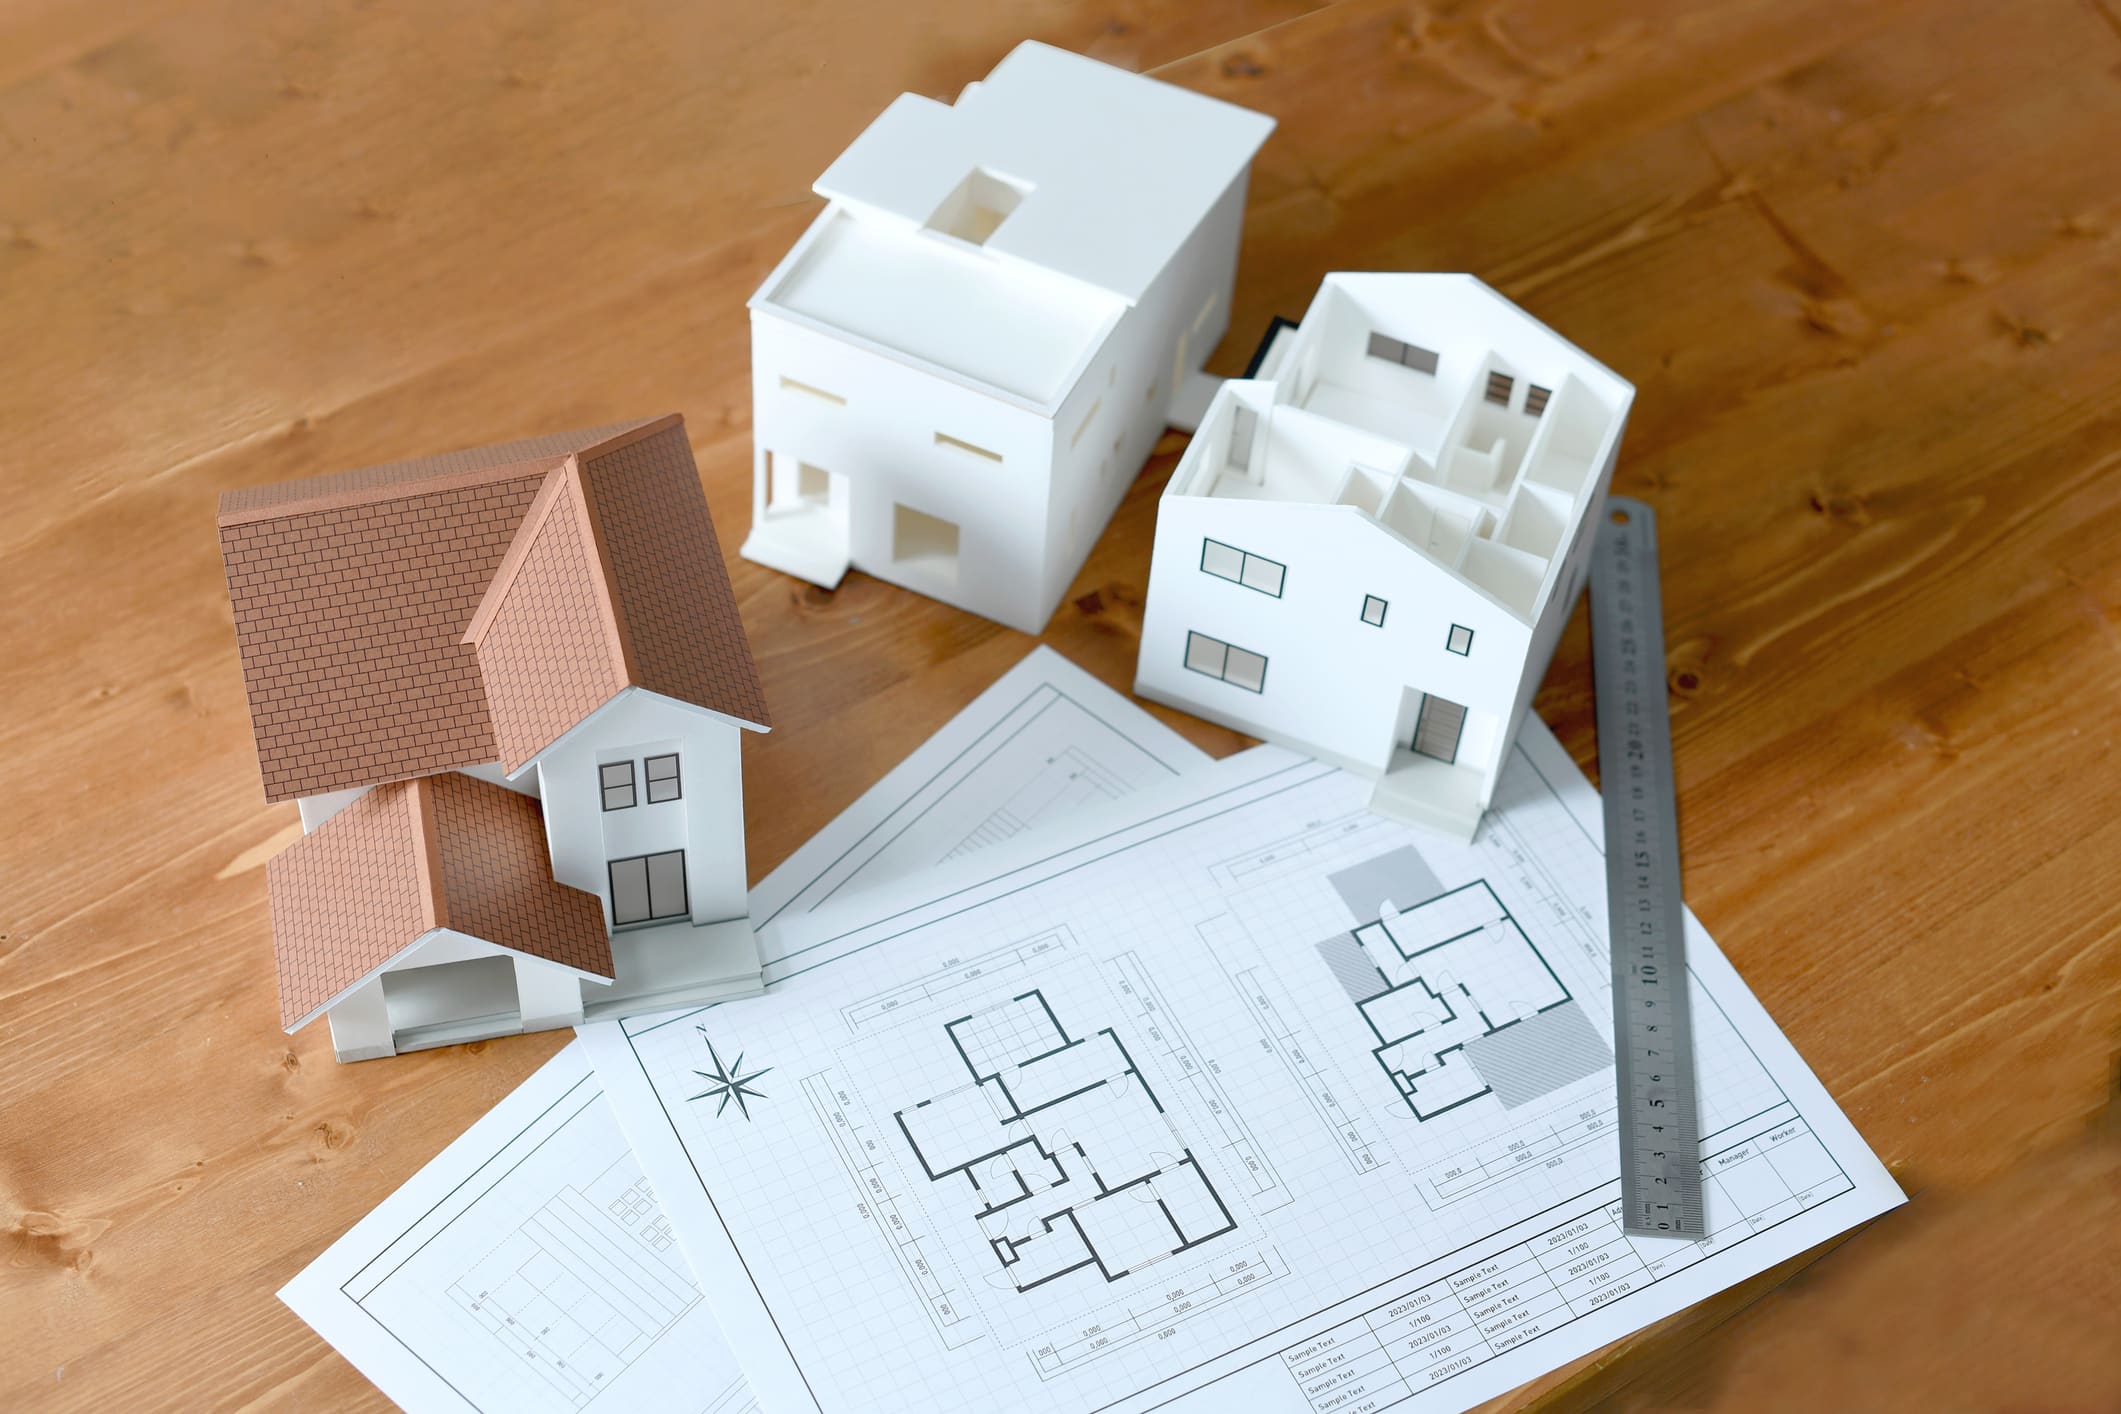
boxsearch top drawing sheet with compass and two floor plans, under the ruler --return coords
[583,721,1900,1414]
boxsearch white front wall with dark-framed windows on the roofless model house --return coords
[1137,496,1529,774]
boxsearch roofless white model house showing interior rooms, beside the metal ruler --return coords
[1135,273,1635,837]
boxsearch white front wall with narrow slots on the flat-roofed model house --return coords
[751,315,1054,634]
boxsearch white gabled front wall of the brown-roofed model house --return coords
[537,687,749,929]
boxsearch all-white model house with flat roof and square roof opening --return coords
[742,45,1273,634]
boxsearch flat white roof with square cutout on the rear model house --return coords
[817,42,1275,303]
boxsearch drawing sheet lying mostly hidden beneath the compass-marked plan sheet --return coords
[280,649,1207,1414]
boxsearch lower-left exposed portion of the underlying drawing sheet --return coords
[280,1041,757,1414]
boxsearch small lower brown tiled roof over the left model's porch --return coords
[265,774,613,1030]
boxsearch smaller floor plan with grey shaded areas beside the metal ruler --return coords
[1317,880,1612,1119]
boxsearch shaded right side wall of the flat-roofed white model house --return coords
[1031,172,1247,614]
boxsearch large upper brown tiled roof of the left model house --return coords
[218,416,766,801]
